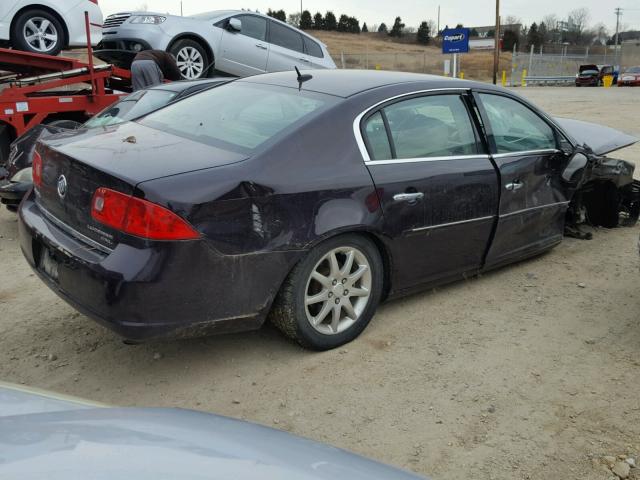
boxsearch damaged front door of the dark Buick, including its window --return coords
[475,92,571,266]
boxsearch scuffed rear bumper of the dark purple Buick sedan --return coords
[19,195,293,341]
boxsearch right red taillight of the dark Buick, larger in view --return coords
[91,188,200,240]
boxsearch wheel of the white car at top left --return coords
[11,8,65,55]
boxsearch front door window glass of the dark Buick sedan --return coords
[480,93,556,153]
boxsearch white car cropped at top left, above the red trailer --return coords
[0,0,102,55]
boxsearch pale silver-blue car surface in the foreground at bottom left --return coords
[0,384,423,480]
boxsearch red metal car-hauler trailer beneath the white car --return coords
[0,44,131,165]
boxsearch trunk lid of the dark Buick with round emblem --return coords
[36,123,246,248]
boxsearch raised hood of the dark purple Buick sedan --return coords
[554,117,638,155]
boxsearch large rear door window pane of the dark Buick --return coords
[384,95,478,159]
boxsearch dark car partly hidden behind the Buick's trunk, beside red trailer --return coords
[0,78,229,211]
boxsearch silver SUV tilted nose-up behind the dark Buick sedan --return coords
[102,10,336,79]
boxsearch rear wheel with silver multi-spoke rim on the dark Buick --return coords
[271,234,384,350]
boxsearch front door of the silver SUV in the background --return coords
[216,14,269,77]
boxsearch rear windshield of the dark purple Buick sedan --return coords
[139,82,337,153]
